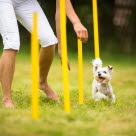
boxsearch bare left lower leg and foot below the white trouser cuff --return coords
[0,49,17,107]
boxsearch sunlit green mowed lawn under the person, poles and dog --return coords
[0,53,136,136]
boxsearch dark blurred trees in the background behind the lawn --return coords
[0,0,136,54]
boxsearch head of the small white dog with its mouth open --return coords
[94,65,113,84]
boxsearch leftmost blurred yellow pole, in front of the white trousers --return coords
[31,13,39,120]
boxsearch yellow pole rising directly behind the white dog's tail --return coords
[92,0,100,58]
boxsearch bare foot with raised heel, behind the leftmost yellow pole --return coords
[40,84,60,102]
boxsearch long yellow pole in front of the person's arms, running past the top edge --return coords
[60,0,70,112]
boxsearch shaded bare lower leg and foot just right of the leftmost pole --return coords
[40,45,59,101]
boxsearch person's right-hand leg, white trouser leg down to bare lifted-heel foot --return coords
[15,0,59,101]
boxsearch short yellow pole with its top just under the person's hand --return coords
[78,39,83,104]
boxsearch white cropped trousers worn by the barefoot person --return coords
[0,0,58,50]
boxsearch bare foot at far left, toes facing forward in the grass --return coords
[2,98,15,108]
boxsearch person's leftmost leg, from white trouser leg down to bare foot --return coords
[0,2,20,107]
